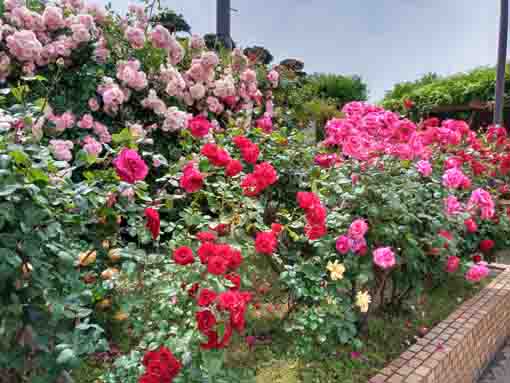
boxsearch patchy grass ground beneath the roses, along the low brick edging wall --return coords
[73,276,488,383]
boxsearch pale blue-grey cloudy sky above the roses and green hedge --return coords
[102,0,500,101]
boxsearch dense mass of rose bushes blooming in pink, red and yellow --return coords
[0,0,510,383]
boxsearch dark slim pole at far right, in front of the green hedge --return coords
[494,0,508,125]
